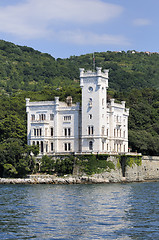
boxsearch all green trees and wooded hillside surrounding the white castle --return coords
[0,41,159,176]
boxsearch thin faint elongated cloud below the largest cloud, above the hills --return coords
[57,31,130,46]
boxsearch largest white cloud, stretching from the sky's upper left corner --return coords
[0,0,123,39]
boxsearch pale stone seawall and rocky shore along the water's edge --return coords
[0,156,159,184]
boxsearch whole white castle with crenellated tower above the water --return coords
[26,67,129,155]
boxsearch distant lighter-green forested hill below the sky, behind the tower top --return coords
[0,40,159,92]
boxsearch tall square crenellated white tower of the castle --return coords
[80,67,109,153]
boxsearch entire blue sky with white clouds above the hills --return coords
[0,0,159,59]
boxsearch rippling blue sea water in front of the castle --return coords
[0,182,159,240]
